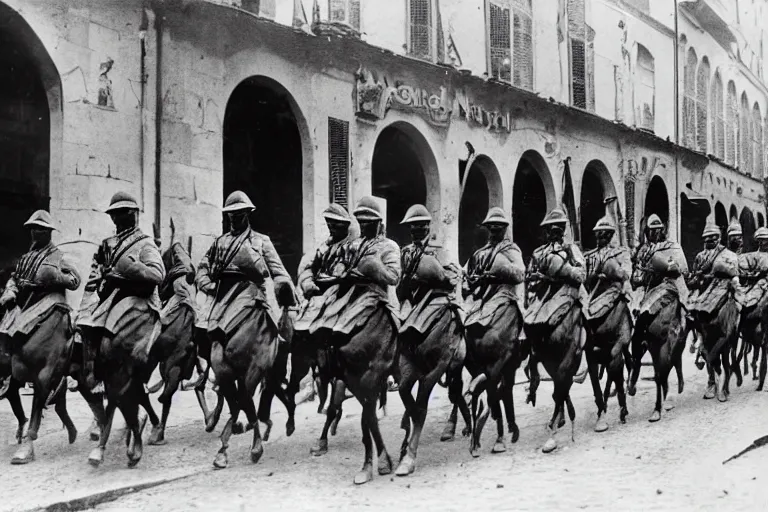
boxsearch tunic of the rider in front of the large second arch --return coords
[196,228,294,337]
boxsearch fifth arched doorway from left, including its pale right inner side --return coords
[512,150,555,265]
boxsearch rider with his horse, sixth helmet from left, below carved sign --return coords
[395,204,466,476]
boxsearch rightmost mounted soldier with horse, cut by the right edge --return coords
[738,227,768,391]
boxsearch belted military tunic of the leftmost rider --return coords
[0,243,80,337]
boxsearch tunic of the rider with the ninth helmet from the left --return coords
[584,246,632,319]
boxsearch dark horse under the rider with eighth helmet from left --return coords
[525,303,584,453]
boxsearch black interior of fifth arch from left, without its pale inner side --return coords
[512,158,547,265]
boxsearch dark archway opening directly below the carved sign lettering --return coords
[371,126,434,250]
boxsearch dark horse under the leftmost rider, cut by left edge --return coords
[0,309,77,464]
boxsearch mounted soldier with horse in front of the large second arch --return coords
[196,190,295,469]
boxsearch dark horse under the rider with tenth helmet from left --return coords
[627,298,689,422]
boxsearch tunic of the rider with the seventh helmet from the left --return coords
[463,238,525,327]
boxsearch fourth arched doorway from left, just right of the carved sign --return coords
[459,155,504,265]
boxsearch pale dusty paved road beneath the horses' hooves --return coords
[0,354,768,512]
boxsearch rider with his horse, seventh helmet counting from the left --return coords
[460,207,528,457]
